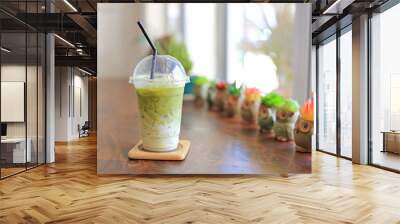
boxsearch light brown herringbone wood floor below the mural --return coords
[0,137,400,224]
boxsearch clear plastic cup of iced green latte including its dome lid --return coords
[130,55,188,152]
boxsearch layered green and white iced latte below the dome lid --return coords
[136,78,185,151]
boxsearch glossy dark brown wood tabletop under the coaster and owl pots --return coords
[97,101,311,175]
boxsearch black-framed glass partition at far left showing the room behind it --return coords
[0,1,46,178]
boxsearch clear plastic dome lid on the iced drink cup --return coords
[129,55,189,88]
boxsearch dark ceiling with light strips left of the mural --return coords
[0,0,97,74]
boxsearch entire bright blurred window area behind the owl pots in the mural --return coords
[165,3,310,96]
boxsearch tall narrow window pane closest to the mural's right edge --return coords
[317,37,337,154]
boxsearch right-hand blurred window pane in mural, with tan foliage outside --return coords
[227,4,296,93]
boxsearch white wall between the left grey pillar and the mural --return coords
[55,67,89,141]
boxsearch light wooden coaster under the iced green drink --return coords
[128,140,190,160]
